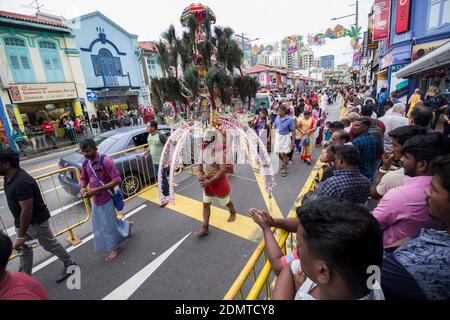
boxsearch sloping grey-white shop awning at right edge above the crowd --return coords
[397,42,450,79]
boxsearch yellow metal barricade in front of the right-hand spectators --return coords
[224,161,323,300]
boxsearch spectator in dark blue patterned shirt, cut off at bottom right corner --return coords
[381,155,450,300]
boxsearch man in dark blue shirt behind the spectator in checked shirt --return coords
[352,118,378,179]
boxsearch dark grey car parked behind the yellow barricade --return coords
[58,125,171,198]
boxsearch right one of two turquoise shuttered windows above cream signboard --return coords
[39,41,65,82]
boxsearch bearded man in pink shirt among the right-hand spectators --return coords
[373,133,450,247]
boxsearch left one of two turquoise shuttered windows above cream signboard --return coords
[4,37,36,83]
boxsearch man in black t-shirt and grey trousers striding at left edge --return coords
[0,151,75,283]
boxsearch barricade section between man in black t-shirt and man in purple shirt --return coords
[0,167,91,259]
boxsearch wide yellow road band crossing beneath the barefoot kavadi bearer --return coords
[139,188,260,242]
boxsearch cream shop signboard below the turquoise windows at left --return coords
[8,82,78,103]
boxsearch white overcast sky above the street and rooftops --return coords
[4,0,373,64]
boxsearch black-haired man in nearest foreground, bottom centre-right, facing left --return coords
[265,199,384,300]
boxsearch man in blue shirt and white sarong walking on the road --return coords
[273,105,295,177]
